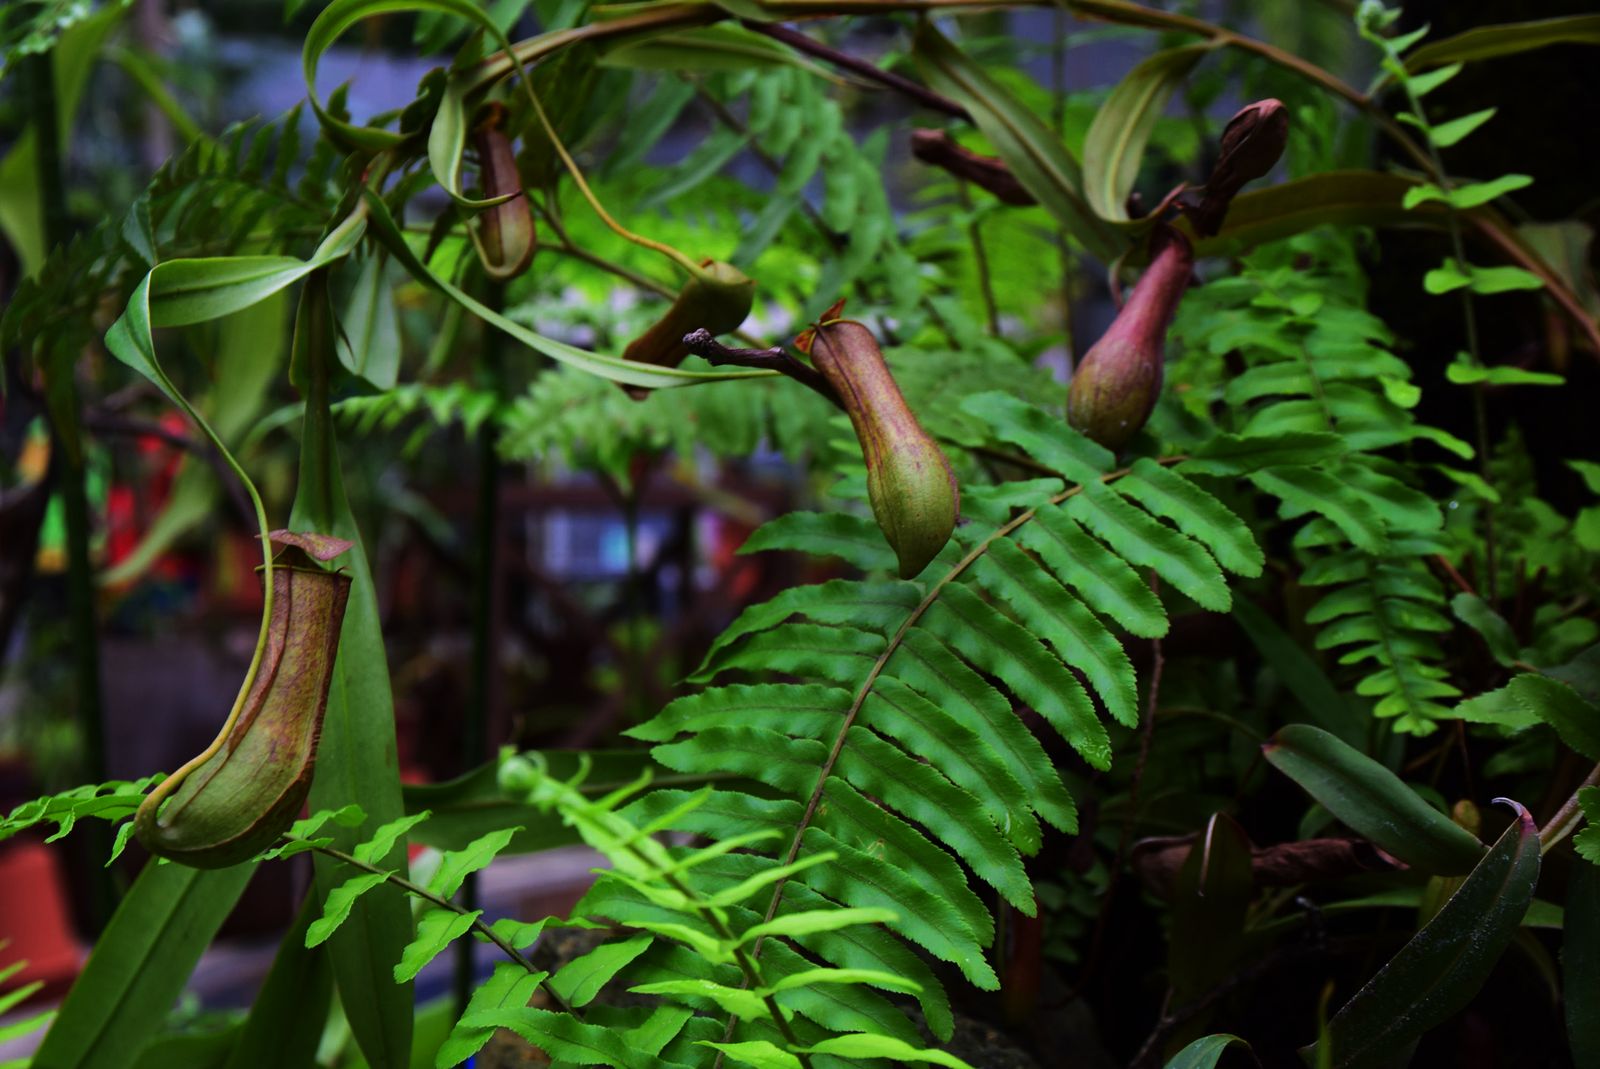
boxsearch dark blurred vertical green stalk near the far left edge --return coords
[27,51,117,933]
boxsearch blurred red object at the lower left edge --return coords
[0,839,83,999]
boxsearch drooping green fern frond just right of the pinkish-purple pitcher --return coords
[1176,235,1472,735]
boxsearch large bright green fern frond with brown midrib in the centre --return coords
[617,394,1272,1023]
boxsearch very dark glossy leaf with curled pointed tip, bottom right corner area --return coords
[1318,802,1539,1069]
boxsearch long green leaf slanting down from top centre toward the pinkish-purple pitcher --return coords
[912,19,1126,262]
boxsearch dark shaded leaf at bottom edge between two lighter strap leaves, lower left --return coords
[222,895,333,1069]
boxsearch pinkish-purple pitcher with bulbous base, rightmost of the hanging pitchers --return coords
[1067,226,1194,450]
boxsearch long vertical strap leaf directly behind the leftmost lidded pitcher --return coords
[290,272,413,1069]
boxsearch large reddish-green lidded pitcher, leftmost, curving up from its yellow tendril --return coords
[134,531,350,869]
